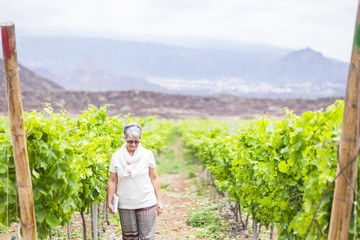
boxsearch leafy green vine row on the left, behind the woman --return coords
[0,106,173,236]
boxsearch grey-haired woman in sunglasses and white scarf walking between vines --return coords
[108,123,163,239]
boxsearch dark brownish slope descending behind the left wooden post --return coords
[0,59,63,92]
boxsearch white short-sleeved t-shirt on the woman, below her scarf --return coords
[109,146,157,209]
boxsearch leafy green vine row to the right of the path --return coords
[176,101,360,239]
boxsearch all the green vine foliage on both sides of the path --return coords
[0,101,360,239]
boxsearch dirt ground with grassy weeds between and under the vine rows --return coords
[0,136,272,240]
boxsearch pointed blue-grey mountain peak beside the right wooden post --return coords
[245,48,349,96]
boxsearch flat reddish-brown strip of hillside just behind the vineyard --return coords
[0,91,336,118]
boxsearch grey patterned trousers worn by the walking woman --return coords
[119,205,156,240]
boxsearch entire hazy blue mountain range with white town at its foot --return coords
[1,37,348,98]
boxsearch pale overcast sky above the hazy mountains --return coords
[0,0,358,62]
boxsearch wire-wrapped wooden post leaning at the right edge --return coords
[328,2,360,240]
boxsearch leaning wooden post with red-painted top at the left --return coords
[0,22,37,240]
